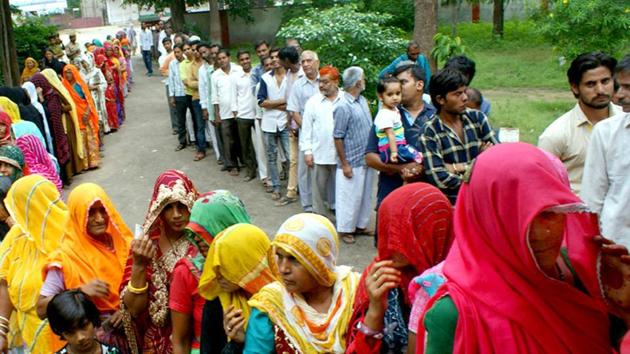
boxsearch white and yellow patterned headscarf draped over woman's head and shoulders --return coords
[248,213,359,354]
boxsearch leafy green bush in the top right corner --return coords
[537,0,630,60]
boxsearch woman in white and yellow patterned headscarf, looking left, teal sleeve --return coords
[246,214,359,354]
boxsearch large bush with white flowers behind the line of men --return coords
[276,5,406,98]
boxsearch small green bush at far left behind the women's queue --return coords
[13,17,57,70]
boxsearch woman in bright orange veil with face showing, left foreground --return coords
[37,183,133,352]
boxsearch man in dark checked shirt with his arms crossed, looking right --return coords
[420,69,498,205]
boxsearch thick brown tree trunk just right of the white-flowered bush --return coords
[413,0,438,70]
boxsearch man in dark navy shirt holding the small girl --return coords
[365,63,436,209]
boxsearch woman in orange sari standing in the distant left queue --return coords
[63,65,101,169]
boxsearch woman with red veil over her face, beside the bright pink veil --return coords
[346,182,453,354]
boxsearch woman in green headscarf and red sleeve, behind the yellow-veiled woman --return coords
[169,190,250,354]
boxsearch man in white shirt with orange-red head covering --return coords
[300,66,342,216]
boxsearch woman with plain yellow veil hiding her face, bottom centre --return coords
[199,224,277,352]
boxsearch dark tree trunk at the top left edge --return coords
[0,0,20,86]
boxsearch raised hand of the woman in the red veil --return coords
[365,260,400,316]
